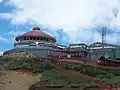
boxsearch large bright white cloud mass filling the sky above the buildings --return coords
[3,0,120,43]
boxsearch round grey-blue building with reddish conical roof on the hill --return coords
[4,27,66,57]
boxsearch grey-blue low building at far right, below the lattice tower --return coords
[89,42,119,59]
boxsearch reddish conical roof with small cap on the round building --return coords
[15,27,56,42]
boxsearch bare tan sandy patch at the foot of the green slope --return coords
[1,71,40,90]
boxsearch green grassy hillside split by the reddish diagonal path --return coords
[1,57,120,85]
